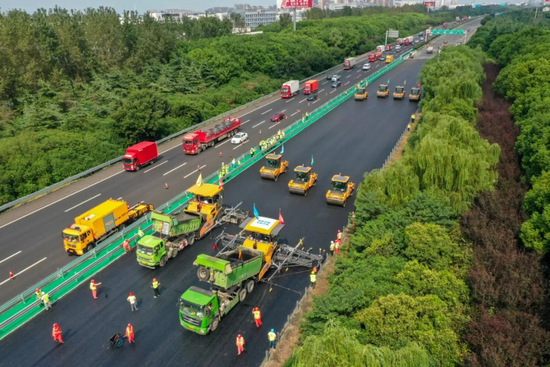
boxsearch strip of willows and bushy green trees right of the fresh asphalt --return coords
[288,47,500,366]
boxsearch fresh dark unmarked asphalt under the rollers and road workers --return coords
[0,55,425,366]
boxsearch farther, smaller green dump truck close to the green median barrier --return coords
[137,211,203,269]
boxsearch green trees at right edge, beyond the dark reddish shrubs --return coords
[468,12,550,254]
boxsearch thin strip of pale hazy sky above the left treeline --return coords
[0,0,280,13]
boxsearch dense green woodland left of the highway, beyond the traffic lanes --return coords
[0,8,434,203]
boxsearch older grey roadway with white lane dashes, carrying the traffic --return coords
[0,41,418,302]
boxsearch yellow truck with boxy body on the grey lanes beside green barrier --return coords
[63,199,154,255]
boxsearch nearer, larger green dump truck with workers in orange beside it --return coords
[179,247,264,335]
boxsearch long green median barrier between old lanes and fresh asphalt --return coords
[0,51,410,339]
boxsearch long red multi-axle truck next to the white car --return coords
[182,117,241,154]
